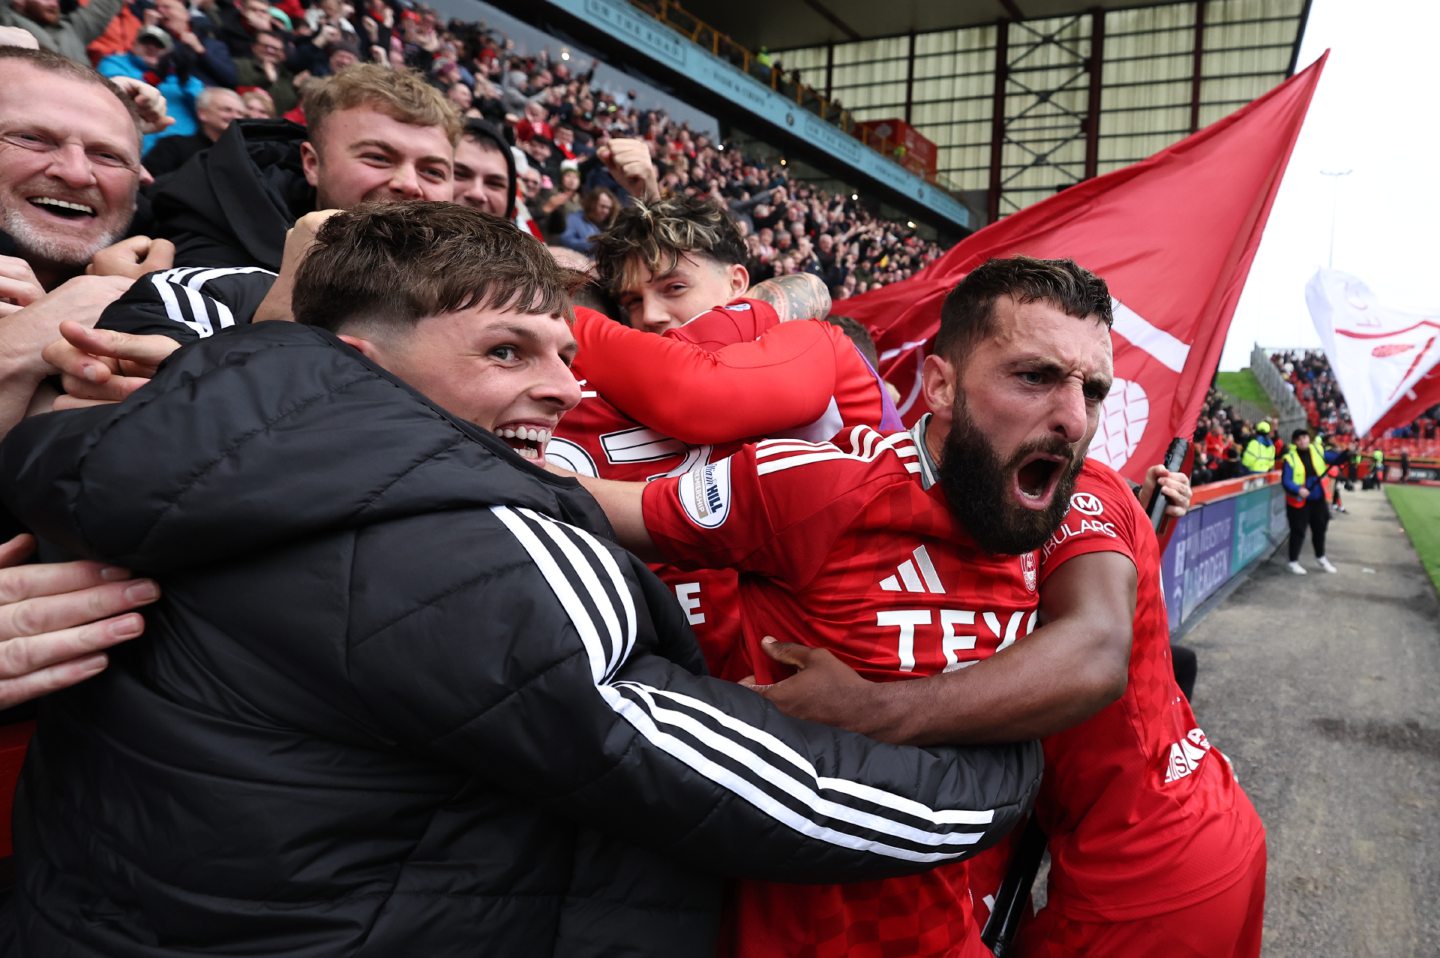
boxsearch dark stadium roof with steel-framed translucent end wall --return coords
[668,0,1310,220]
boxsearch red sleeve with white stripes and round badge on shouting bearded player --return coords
[642,431,909,588]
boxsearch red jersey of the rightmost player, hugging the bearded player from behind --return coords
[973,460,1264,922]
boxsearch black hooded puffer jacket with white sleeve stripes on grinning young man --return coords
[0,323,1040,958]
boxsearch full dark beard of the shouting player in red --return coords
[937,399,1084,556]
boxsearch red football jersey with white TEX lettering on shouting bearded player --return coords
[644,424,1037,958]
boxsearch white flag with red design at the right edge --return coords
[1305,269,1440,437]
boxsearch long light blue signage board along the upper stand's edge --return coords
[546,0,972,229]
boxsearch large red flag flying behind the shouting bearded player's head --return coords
[834,53,1328,481]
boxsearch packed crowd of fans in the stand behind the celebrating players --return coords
[0,0,942,300]
